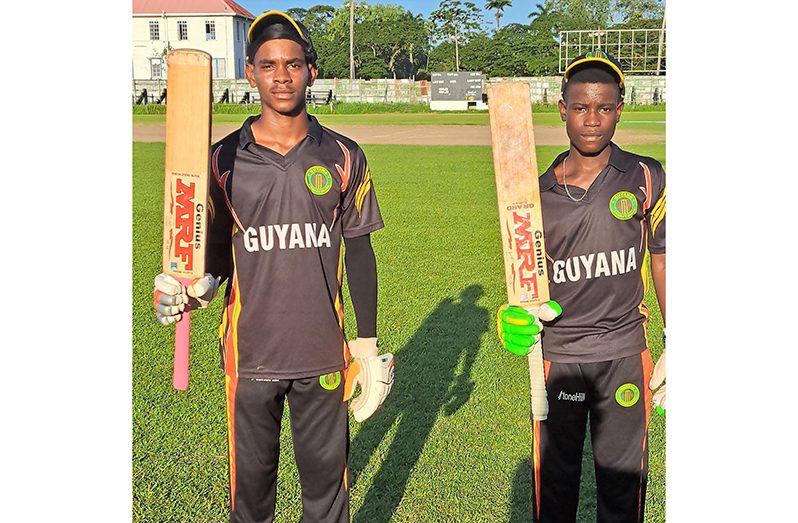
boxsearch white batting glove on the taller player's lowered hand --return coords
[344,338,393,423]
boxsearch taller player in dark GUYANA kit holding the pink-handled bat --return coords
[155,11,393,523]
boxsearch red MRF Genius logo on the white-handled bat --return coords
[505,203,546,302]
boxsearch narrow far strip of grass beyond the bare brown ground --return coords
[133,111,665,132]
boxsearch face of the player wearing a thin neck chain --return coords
[559,83,623,156]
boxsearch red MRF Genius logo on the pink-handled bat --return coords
[169,173,205,272]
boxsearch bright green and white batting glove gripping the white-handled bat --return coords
[496,300,562,356]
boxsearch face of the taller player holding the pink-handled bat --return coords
[246,39,318,115]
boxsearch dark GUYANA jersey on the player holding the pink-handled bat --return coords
[208,116,383,379]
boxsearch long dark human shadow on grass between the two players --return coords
[349,285,490,523]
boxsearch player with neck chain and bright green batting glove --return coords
[498,51,665,523]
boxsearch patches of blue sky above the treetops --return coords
[234,0,537,28]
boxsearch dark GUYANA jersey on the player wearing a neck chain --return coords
[540,143,665,363]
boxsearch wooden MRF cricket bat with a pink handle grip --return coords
[163,49,212,390]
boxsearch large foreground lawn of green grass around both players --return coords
[132,143,665,523]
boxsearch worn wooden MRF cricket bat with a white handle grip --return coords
[488,82,549,420]
